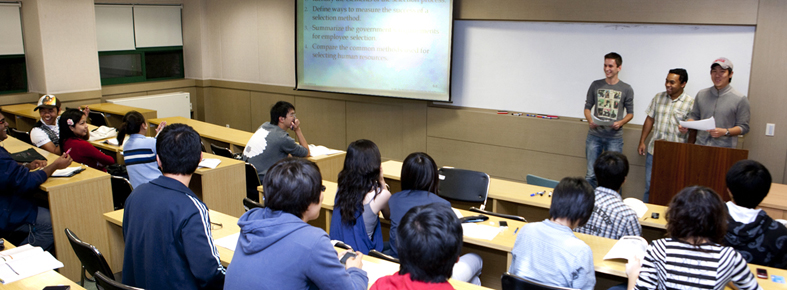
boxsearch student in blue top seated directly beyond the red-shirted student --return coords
[387,152,483,285]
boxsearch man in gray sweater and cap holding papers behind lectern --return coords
[680,57,750,148]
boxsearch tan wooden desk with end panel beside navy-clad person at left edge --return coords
[2,137,113,280]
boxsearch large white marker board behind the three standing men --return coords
[451,21,754,124]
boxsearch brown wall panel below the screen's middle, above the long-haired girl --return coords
[346,102,410,160]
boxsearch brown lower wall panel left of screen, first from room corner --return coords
[205,88,252,132]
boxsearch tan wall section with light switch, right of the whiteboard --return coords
[744,0,787,183]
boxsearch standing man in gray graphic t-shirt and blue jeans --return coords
[585,52,634,188]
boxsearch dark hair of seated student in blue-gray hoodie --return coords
[262,157,322,218]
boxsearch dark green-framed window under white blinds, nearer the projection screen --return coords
[98,46,184,85]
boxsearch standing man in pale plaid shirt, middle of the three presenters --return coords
[637,68,697,202]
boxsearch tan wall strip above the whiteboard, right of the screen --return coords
[454,0,758,25]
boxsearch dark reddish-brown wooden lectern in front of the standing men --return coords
[648,140,749,206]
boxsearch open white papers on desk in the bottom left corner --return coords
[0,245,63,284]
